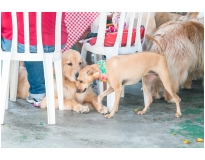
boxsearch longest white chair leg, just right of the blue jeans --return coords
[43,53,56,124]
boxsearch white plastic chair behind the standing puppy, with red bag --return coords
[81,12,149,111]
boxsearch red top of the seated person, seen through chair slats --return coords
[1,12,68,46]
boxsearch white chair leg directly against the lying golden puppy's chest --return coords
[54,59,64,110]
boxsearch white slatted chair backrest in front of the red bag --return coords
[90,12,149,54]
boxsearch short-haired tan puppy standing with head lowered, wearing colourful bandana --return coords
[78,52,181,118]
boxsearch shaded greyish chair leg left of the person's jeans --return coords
[9,61,19,101]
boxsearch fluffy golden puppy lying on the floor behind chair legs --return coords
[18,49,108,114]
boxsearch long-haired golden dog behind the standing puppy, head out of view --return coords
[146,21,204,102]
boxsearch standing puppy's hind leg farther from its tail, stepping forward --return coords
[137,74,157,115]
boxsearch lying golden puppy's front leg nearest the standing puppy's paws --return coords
[84,93,108,114]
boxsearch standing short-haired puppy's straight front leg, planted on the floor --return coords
[105,84,122,118]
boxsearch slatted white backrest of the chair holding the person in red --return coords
[5,12,62,61]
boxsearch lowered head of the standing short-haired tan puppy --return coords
[76,64,101,93]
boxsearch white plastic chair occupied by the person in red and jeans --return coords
[0,12,63,124]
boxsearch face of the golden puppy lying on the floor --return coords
[62,49,86,82]
